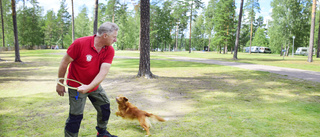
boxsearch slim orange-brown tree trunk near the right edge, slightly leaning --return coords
[308,0,317,62]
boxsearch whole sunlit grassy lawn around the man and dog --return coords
[0,50,320,137]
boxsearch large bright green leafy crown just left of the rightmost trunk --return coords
[268,0,312,53]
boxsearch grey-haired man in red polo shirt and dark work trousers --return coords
[56,22,119,137]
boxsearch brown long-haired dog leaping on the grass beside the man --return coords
[116,95,165,135]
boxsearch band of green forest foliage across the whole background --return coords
[0,0,319,56]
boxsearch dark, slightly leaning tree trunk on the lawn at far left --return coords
[11,0,22,62]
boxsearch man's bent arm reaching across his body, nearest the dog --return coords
[78,63,111,94]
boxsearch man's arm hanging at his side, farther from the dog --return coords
[56,54,73,96]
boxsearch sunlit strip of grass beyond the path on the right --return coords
[148,51,320,72]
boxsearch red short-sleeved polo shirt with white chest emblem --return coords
[67,35,114,93]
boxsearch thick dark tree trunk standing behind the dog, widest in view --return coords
[137,0,156,79]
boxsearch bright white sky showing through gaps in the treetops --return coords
[18,0,272,24]
